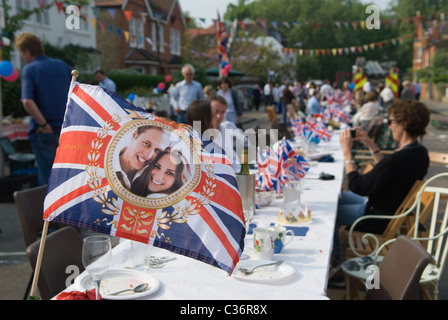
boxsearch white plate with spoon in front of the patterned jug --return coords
[232,260,295,283]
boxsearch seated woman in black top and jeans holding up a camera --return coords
[334,100,430,263]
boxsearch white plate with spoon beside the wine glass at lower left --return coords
[75,270,160,300]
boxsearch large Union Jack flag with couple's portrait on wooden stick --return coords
[43,82,245,274]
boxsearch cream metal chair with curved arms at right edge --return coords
[342,172,448,300]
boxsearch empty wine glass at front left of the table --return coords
[82,236,112,300]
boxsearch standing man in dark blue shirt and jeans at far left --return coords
[15,32,72,185]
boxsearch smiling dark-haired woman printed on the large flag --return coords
[131,149,186,197]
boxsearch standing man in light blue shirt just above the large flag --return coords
[170,64,205,123]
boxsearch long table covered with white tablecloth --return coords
[61,134,344,300]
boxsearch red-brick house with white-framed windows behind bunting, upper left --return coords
[95,0,186,75]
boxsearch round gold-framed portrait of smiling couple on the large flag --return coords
[105,120,201,208]
